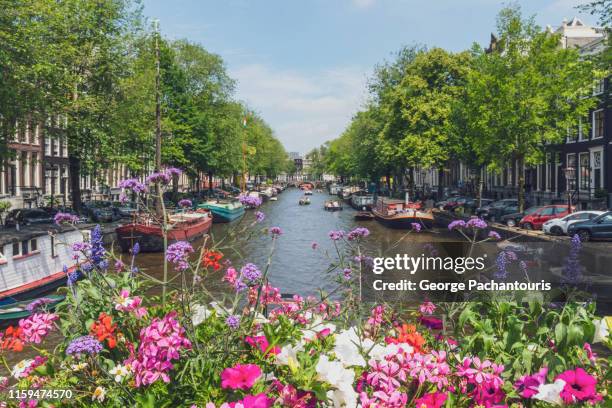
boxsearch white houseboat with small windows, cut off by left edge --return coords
[0,224,89,305]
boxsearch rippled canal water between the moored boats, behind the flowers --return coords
[136,188,457,295]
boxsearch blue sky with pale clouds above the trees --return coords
[144,0,595,153]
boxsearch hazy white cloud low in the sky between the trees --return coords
[230,64,366,153]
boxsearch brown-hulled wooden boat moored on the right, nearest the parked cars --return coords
[372,197,434,229]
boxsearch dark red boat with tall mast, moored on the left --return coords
[115,208,213,252]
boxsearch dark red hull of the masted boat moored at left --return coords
[115,217,213,252]
